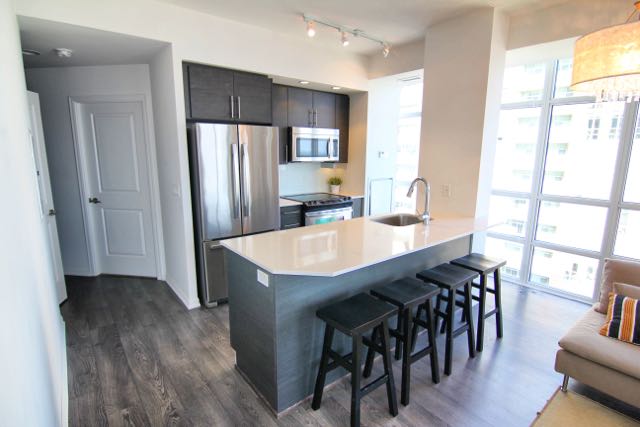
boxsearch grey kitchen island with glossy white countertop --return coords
[222,217,488,414]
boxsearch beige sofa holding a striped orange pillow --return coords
[555,259,640,408]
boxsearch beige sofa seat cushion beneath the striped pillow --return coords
[558,309,640,379]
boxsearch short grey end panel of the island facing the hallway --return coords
[225,249,277,410]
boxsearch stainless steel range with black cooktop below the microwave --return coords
[283,193,353,225]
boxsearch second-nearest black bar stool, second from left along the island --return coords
[363,278,440,406]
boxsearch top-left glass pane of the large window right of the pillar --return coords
[502,63,545,104]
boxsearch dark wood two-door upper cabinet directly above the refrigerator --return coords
[183,63,271,124]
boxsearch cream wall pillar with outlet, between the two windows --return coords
[418,8,507,217]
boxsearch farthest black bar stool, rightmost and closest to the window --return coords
[451,253,507,351]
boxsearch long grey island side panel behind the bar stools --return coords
[272,236,472,412]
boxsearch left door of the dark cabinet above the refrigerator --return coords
[187,64,233,121]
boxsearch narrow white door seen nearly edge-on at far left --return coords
[27,92,67,304]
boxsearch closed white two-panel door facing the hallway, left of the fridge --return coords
[71,99,157,277]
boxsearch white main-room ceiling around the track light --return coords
[158,0,568,54]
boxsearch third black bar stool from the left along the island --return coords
[417,264,478,375]
